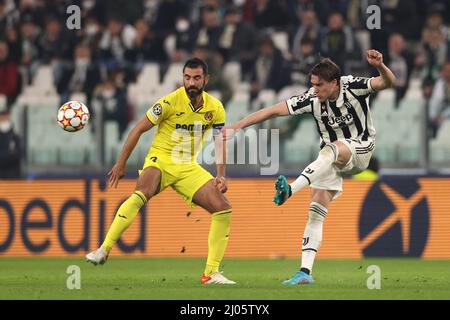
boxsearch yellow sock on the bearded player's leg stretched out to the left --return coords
[102,191,147,252]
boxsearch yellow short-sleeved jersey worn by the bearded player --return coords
[146,87,226,163]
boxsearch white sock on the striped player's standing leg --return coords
[301,202,328,274]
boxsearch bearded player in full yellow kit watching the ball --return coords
[86,58,235,284]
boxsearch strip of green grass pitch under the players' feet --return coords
[0,257,450,300]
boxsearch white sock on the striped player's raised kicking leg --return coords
[290,143,338,194]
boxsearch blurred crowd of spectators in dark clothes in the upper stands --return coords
[0,0,450,178]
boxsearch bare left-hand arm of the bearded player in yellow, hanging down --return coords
[108,115,154,188]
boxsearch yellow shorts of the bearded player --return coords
[139,153,214,207]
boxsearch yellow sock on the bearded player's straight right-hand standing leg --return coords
[204,209,231,276]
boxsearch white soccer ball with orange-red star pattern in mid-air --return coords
[58,101,90,132]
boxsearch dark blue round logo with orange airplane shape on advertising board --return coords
[359,178,430,257]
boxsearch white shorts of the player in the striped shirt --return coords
[310,139,375,199]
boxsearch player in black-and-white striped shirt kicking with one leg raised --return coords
[222,50,395,285]
